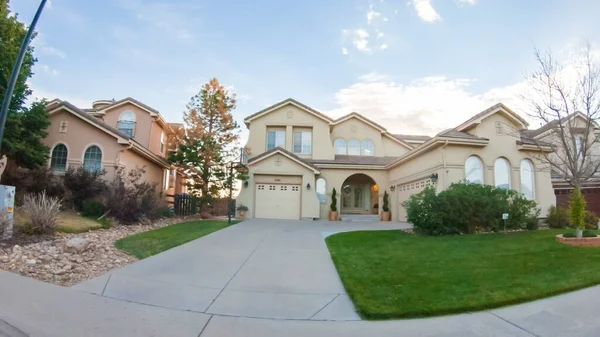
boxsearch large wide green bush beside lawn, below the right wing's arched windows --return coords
[402,183,539,235]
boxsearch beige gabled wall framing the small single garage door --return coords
[237,154,319,219]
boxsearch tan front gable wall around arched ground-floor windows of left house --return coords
[43,111,126,179]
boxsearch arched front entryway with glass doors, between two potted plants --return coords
[340,173,379,214]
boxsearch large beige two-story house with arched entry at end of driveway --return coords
[237,99,555,221]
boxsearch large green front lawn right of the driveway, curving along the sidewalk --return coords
[326,230,600,319]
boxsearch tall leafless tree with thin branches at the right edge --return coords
[523,43,600,187]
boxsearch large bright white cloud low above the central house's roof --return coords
[328,73,526,135]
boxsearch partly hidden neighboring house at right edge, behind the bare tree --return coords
[526,112,600,216]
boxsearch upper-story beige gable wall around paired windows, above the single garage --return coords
[246,105,334,159]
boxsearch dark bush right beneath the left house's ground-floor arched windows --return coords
[63,166,107,211]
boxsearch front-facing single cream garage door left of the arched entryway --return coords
[254,184,300,219]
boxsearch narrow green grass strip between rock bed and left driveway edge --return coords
[115,220,234,259]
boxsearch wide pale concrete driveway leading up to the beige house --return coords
[70,220,409,321]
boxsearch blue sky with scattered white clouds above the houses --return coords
[9,0,600,143]
